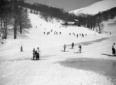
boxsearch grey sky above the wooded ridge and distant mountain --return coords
[26,0,101,11]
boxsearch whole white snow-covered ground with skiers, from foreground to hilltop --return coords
[0,14,116,85]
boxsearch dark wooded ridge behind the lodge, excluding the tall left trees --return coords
[30,3,116,33]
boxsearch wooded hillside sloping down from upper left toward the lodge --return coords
[27,3,77,21]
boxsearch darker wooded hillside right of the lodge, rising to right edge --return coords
[76,7,116,33]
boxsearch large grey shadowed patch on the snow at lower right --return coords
[59,58,116,84]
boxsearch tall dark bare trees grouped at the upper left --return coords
[0,0,31,39]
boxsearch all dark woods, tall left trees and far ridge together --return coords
[0,0,116,39]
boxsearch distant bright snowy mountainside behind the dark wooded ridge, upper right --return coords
[70,0,116,15]
